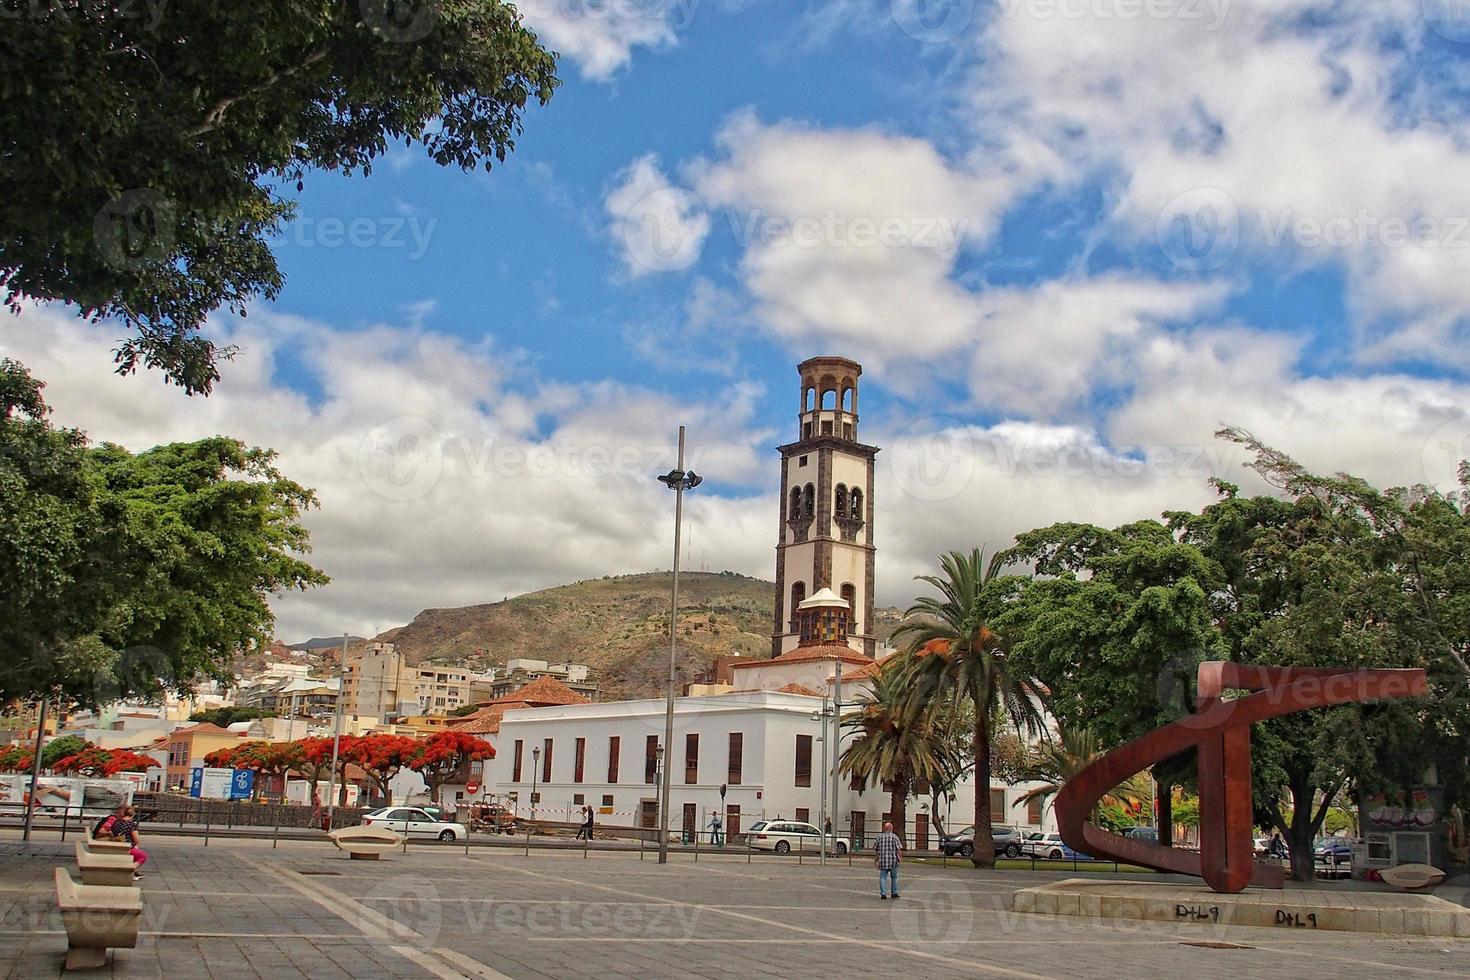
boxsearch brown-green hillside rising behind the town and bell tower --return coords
[378,572,898,701]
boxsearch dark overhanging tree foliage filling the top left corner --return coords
[0,0,559,392]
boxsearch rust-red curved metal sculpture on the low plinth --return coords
[1057,661,1426,893]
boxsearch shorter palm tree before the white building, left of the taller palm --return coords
[839,667,964,840]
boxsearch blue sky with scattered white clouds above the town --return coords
[0,0,1470,639]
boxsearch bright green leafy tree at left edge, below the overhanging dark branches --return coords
[0,360,328,707]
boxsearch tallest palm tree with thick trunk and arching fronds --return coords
[894,548,1042,868]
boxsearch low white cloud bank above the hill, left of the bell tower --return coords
[0,309,776,639]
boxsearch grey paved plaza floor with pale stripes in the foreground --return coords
[0,833,1470,980]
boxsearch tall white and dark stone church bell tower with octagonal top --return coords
[770,357,878,657]
